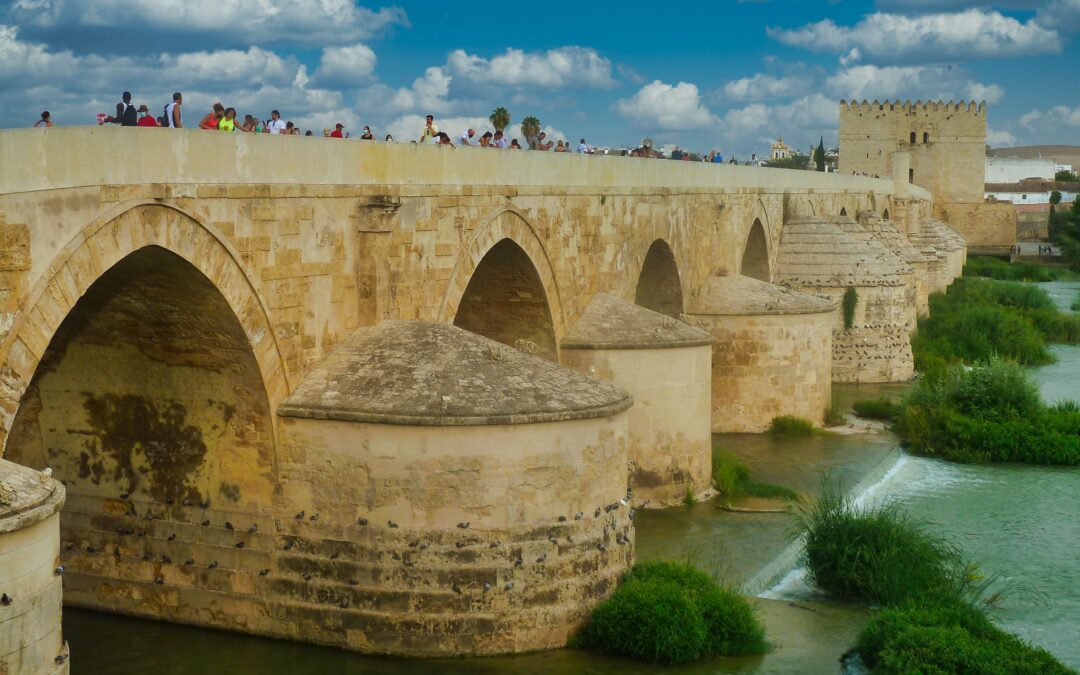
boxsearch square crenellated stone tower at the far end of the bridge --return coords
[840,100,1016,249]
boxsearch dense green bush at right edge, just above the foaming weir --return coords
[893,359,1080,464]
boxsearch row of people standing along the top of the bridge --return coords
[35,92,786,165]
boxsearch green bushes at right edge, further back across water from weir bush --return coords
[912,278,1080,376]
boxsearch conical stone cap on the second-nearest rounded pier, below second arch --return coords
[562,293,713,349]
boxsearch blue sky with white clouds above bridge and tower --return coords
[0,0,1080,157]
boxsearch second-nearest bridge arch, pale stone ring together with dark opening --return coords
[440,208,564,361]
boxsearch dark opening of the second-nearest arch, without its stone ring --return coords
[454,239,558,361]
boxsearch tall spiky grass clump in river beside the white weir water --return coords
[799,488,969,605]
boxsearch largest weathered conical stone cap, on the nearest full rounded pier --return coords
[278,321,633,427]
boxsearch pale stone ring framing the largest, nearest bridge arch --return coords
[0,201,291,456]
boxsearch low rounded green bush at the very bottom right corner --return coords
[856,603,1072,675]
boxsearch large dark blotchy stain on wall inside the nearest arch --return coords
[80,393,206,500]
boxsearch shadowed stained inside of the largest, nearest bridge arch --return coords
[4,245,275,604]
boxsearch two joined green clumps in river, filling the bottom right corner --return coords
[801,490,1071,675]
